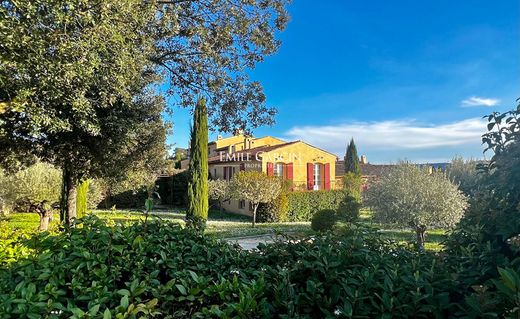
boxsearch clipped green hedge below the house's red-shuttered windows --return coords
[287,190,349,222]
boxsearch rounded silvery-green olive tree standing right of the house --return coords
[366,163,468,250]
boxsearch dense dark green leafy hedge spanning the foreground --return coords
[0,219,519,319]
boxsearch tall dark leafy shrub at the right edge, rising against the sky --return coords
[448,100,520,262]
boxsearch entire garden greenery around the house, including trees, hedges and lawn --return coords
[0,0,520,319]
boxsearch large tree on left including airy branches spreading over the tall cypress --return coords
[0,0,288,222]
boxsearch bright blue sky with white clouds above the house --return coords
[168,0,520,163]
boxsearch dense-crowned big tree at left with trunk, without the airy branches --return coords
[0,0,164,223]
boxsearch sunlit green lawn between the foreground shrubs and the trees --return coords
[1,209,446,251]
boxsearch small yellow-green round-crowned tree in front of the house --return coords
[230,171,282,227]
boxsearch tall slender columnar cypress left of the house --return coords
[186,98,208,225]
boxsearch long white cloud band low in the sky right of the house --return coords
[285,118,486,159]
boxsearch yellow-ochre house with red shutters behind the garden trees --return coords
[208,135,337,215]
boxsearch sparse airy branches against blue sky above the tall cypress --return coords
[151,0,290,132]
